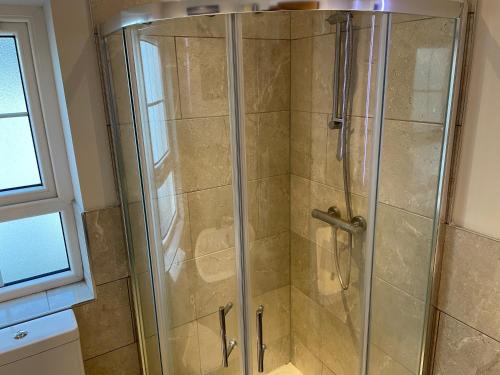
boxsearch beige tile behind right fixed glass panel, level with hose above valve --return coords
[379,120,443,217]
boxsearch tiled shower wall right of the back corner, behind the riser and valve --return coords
[291,13,453,375]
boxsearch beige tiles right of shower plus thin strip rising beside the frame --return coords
[432,1,500,375]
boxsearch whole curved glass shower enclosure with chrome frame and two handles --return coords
[100,0,467,375]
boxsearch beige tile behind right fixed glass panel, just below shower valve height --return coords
[374,204,433,301]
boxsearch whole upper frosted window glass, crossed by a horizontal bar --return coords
[0,37,42,191]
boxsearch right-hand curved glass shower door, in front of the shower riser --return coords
[238,11,382,375]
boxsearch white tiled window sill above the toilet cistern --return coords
[0,280,95,328]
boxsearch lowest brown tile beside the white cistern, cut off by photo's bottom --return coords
[85,344,141,375]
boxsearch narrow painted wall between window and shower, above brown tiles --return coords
[45,0,117,210]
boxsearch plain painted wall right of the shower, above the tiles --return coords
[453,0,500,239]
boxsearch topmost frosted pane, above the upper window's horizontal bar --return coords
[0,36,27,114]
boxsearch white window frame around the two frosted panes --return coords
[0,6,83,302]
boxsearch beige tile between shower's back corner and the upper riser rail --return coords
[291,34,335,113]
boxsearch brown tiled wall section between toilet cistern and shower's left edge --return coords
[74,207,140,375]
